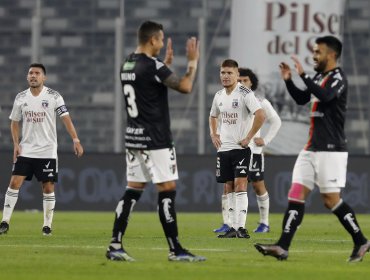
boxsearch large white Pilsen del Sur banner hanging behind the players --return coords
[230,0,345,155]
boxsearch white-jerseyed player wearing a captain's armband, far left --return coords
[0,63,83,235]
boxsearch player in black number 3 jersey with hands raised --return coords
[106,21,205,262]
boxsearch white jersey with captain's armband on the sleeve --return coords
[9,86,68,158]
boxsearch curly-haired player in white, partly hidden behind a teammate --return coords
[214,68,281,233]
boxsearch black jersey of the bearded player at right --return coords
[286,68,348,151]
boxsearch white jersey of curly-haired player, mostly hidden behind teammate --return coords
[248,95,281,154]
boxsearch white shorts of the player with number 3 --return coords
[126,148,179,184]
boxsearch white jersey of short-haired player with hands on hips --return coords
[210,83,261,152]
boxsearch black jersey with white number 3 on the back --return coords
[120,53,173,150]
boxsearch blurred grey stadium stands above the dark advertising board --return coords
[0,0,370,155]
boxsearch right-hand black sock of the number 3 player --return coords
[158,191,182,251]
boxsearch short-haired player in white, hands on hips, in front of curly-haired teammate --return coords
[209,59,265,238]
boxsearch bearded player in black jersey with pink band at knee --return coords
[255,36,370,262]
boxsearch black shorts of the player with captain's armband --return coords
[12,157,58,182]
